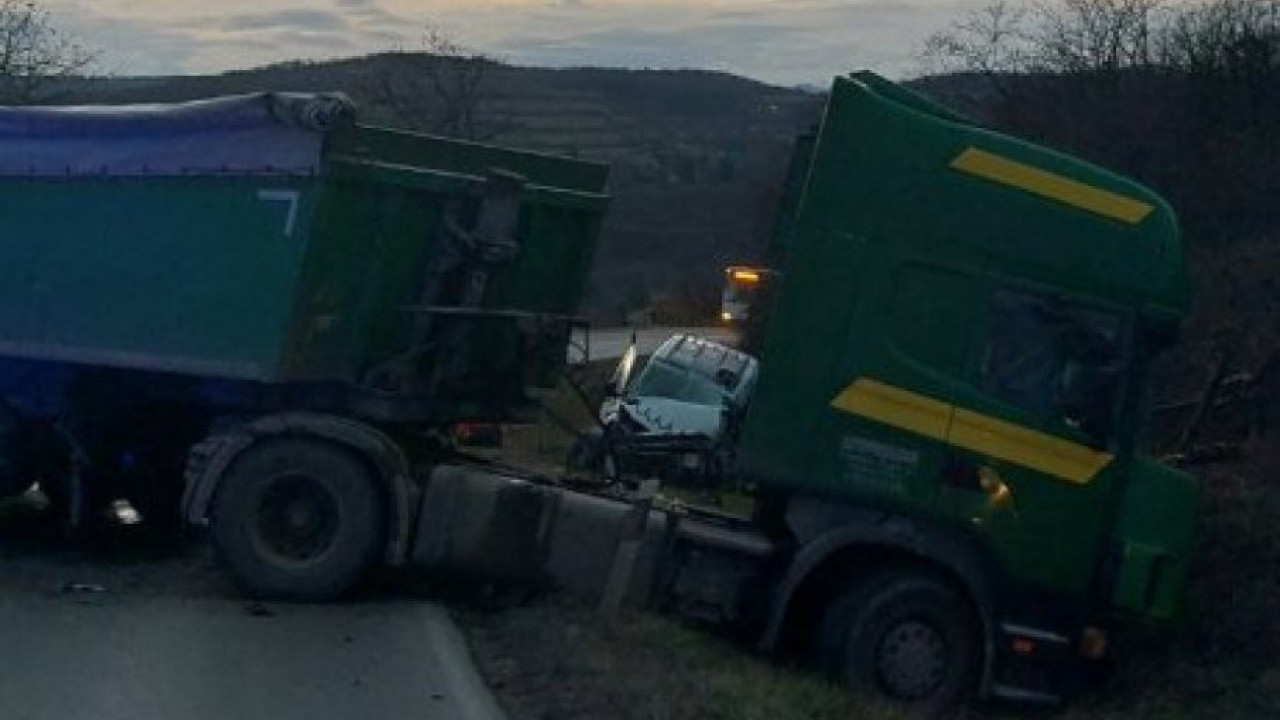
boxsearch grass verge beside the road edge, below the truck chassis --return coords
[457,598,897,720]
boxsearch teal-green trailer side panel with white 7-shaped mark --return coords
[0,177,314,379]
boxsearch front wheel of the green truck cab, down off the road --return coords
[815,571,980,716]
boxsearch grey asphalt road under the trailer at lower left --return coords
[0,497,502,720]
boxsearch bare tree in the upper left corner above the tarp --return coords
[0,0,95,105]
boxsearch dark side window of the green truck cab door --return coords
[979,291,1124,445]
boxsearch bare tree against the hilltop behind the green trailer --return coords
[367,26,500,140]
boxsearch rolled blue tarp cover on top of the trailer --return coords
[0,92,355,177]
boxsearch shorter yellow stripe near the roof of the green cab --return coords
[951,147,1156,225]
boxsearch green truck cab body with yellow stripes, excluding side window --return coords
[741,76,1189,598]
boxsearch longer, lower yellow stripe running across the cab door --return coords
[831,378,1114,484]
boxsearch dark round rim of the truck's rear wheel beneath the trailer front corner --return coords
[253,473,340,565]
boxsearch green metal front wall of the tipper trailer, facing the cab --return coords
[288,127,607,383]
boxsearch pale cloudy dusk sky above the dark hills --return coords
[45,0,977,85]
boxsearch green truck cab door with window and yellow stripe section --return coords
[937,288,1129,597]
